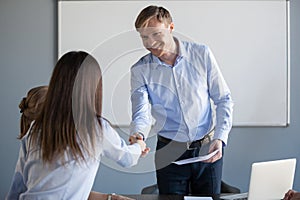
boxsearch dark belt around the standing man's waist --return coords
[157,130,214,150]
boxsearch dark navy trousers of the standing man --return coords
[155,140,223,195]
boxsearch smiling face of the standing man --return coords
[138,18,173,57]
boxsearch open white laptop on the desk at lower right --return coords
[221,158,296,200]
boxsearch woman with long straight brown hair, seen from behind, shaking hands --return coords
[7,52,148,199]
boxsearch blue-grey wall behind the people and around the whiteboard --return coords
[0,0,300,199]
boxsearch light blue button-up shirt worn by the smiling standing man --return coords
[130,38,233,144]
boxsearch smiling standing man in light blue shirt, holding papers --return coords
[129,6,233,195]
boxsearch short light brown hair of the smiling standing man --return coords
[135,5,173,29]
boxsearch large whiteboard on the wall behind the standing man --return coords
[58,0,289,126]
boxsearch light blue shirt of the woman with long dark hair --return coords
[6,119,141,200]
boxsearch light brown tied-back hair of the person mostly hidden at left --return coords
[18,86,48,139]
